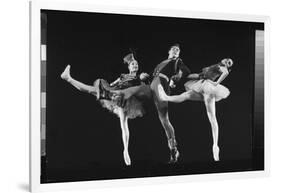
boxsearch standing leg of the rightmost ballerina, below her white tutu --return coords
[204,95,220,161]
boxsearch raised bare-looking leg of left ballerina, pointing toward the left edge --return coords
[61,65,97,95]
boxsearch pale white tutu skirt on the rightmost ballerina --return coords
[184,80,230,101]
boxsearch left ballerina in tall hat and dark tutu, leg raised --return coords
[61,54,151,165]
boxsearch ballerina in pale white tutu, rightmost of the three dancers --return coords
[158,58,233,161]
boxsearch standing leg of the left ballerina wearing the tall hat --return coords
[118,108,131,165]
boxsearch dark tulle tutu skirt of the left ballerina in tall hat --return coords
[94,79,150,119]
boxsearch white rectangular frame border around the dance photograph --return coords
[29,0,271,192]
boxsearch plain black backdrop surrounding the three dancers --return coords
[42,10,263,183]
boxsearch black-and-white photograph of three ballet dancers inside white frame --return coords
[40,9,264,184]
